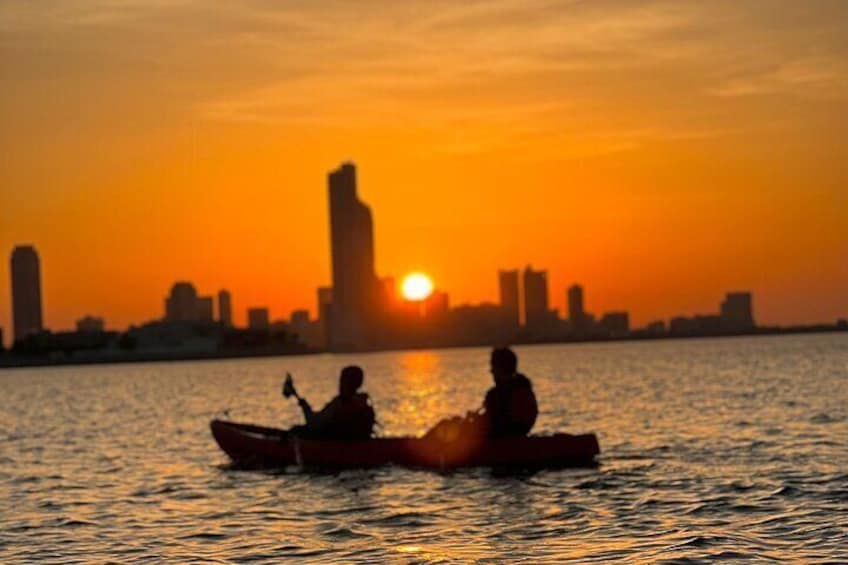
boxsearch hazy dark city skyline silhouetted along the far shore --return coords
[0,161,844,351]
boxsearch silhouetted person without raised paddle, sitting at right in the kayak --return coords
[479,347,539,438]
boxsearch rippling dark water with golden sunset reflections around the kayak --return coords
[0,334,848,563]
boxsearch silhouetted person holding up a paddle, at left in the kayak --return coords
[283,365,375,440]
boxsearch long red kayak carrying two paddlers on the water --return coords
[210,420,600,469]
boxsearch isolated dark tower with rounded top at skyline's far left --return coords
[11,245,43,341]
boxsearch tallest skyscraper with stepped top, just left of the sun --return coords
[327,163,379,350]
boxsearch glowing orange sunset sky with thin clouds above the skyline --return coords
[0,0,848,341]
